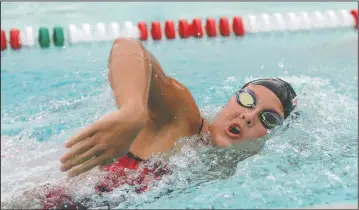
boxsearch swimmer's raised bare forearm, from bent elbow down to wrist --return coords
[108,38,152,114]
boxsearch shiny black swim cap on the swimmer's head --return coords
[242,78,297,119]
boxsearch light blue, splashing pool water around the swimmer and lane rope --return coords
[1,2,358,208]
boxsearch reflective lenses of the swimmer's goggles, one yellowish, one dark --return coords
[236,88,283,130]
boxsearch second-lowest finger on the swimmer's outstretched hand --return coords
[60,146,104,171]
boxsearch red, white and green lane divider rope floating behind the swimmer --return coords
[1,9,358,51]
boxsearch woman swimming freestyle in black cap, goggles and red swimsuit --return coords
[41,38,297,210]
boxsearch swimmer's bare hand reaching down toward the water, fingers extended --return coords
[60,109,145,177]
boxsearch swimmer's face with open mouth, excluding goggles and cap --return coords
[210,85,284,150]
